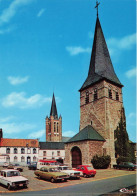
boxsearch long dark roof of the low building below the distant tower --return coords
[39,142,65,150]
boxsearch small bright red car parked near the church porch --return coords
[76,165,96,178]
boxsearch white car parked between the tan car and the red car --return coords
[57,166,81,179]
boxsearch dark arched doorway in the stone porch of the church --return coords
[71,146,82,168]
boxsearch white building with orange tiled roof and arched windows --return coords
[0,130,39,165]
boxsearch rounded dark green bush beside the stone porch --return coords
[91,155,111,169]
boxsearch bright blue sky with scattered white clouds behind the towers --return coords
[0,0,136,142]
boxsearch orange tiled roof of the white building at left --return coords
[0,138,39,148]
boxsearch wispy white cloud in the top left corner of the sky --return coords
[0,0,34,25]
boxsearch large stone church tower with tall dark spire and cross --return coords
[79,3,123,164]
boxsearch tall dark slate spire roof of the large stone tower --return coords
[79,17,123,91]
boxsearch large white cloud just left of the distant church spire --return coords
[2,92,51,109]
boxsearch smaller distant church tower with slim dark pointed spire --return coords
[46,93,62,142]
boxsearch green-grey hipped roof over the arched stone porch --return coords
[66,125,105,143]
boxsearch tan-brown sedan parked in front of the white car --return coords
[34,166,69,183]
